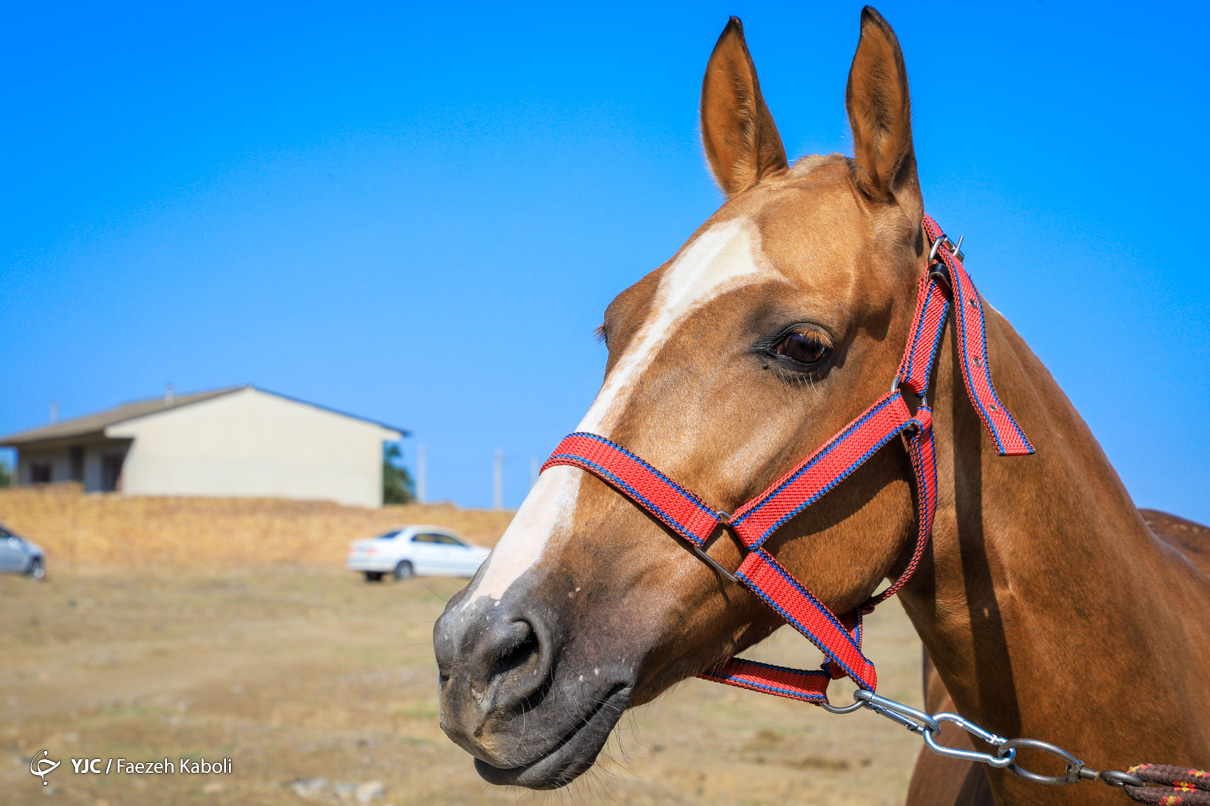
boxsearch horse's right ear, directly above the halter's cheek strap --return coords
[845,6,924,224]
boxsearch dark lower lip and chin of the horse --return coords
[474,685,633,789]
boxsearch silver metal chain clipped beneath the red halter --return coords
[820,689,1146,788]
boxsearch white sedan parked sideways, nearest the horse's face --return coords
[346,525,491,582]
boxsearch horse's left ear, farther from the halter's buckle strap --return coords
[702,17,787,196]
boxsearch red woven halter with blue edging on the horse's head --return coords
[542,215,1033,704]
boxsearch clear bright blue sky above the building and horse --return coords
[0,0,1210,522]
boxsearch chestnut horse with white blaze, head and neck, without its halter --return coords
[434,8,1210,804]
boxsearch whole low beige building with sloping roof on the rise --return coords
[0,386,407,507]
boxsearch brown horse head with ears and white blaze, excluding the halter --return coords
[434,8,928,788]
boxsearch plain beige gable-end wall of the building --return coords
[105,387,402,507]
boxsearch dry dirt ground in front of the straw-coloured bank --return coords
[0,566,920,806]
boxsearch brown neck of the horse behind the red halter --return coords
[901,311,1210,784]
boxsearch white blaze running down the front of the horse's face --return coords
[463,219,772,604]
